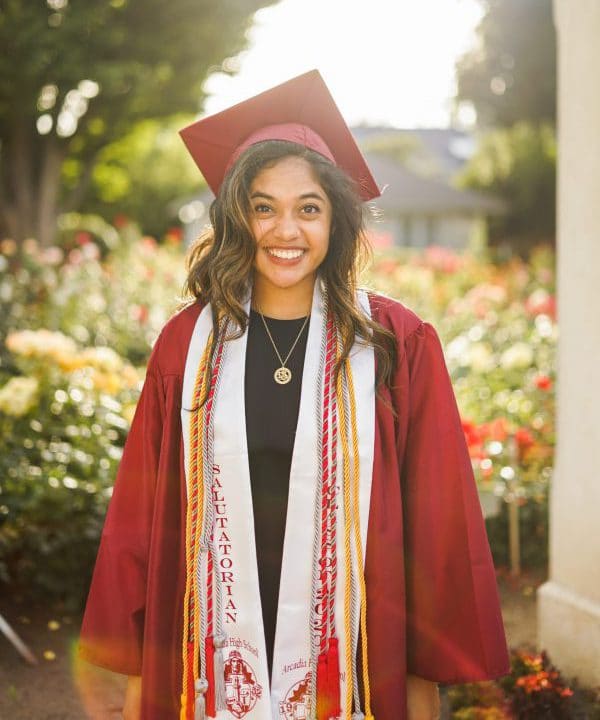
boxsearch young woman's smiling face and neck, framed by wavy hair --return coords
[249,156,332,317]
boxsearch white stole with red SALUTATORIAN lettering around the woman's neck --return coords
[181,278,375,720]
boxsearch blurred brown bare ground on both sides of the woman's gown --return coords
[0,571,545,720]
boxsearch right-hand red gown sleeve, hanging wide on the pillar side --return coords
[402,321,510,683]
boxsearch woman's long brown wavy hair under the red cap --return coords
[183,140,397,400]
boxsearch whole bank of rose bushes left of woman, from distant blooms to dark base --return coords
[0,223,184,606]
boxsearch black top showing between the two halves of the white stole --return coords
[245,310,310,675]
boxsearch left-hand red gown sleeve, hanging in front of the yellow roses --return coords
[79,341,165,675]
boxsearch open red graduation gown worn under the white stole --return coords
[79,294,509,720]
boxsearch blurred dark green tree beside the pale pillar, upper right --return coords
[455,0,556,255]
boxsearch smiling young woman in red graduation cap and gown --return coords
[80,71,509,720]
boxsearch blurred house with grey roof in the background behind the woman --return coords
[176,127,506,250]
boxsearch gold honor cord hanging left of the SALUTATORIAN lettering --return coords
[180,332,212,720]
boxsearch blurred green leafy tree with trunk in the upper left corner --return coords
[0,0,270,242]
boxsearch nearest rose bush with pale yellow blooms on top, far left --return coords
[0,330,143,604]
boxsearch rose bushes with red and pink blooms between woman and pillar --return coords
[368,246,558,566]
